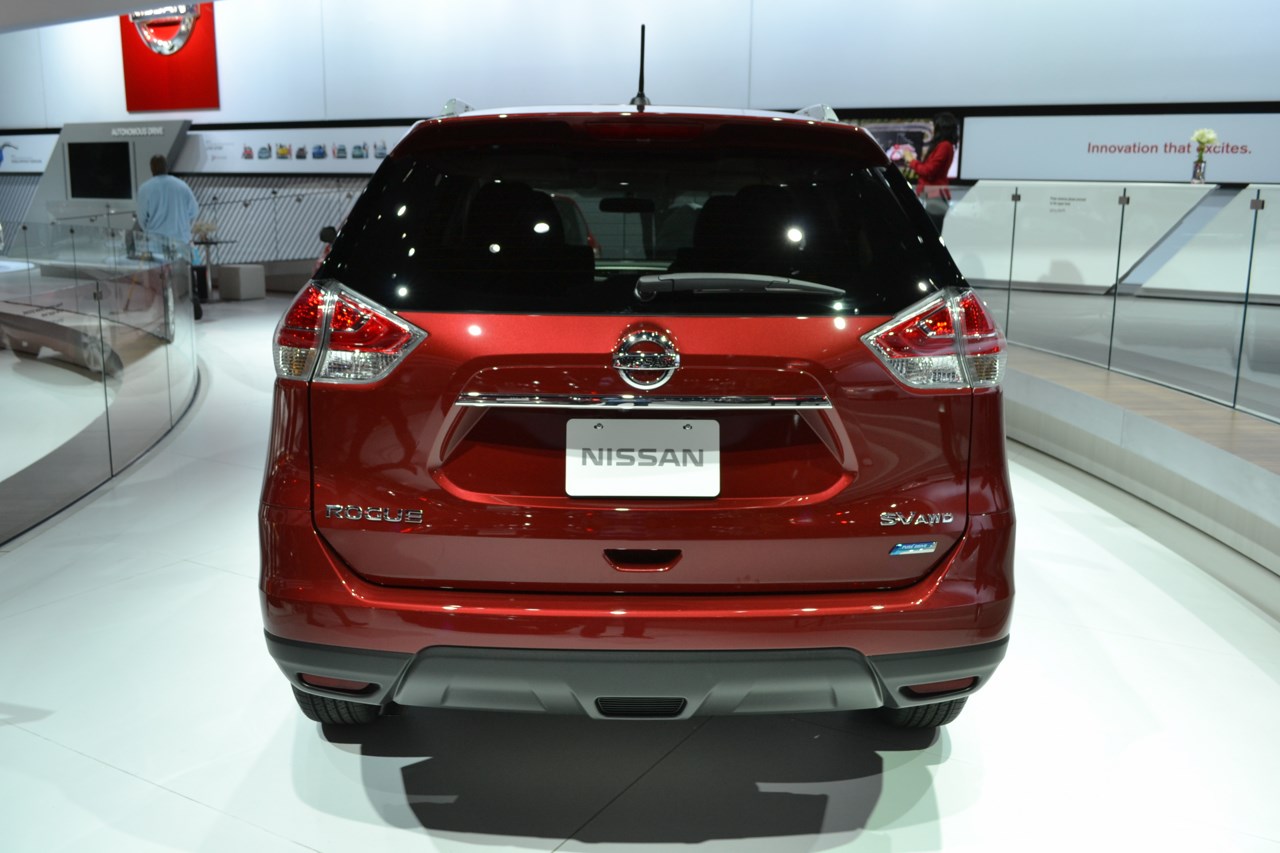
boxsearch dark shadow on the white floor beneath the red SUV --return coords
[314,710,948,849]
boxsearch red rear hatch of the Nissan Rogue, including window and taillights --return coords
[278,109,1000,594]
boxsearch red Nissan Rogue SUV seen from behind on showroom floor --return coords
[261,108,1014,726]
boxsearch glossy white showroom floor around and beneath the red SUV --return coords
[0,297,1280,853]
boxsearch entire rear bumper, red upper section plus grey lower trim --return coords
[261,505,1014,715]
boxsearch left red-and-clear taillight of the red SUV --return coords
[275,282,426,382]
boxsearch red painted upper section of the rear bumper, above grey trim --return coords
[261,506,1014,656]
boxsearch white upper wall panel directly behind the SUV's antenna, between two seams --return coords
[317,0,747,118]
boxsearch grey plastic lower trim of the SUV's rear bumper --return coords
[266,634,1009,719]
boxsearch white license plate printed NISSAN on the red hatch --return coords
[564,418,719,497]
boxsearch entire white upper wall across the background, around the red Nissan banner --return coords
[0,0,1280,128]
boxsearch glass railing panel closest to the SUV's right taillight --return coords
[1005,182,1123,366]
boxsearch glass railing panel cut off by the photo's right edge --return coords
[1235,186,1280,420]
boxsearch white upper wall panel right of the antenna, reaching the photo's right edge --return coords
[751,0,1280,106]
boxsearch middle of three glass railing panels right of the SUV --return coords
[1111,188,1254,405]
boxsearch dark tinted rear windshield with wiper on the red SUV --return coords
[319,121,950,315]
